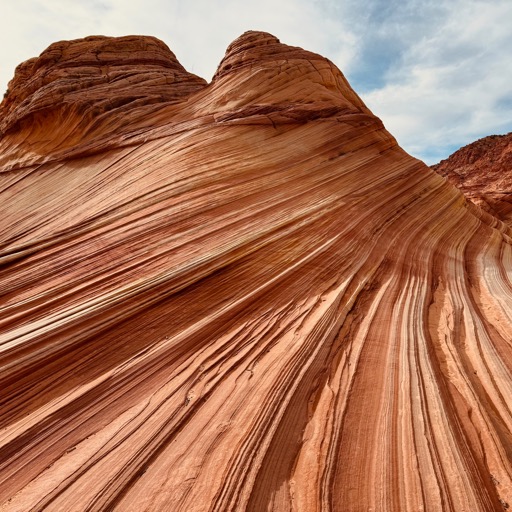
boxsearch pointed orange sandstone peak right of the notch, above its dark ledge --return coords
[208,31,371,124]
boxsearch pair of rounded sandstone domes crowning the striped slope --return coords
[0,31,380,170]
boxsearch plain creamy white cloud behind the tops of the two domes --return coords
[0,0,352,87]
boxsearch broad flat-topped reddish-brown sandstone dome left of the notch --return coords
[0,36,206,168]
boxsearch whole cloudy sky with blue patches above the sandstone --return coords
[0,0,512,163]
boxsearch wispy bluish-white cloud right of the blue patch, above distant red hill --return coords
[363,0,512,163]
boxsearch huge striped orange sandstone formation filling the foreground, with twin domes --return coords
[0,32,512,512]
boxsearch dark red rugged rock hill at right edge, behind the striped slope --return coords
[432,132,512,226]
